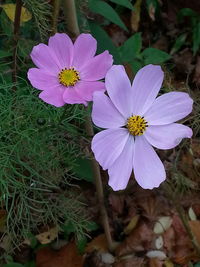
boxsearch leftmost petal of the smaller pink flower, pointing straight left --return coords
[28,68,59,90]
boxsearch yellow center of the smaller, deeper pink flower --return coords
[58,68,80,87]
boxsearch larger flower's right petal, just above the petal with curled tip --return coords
[144,92,193,125]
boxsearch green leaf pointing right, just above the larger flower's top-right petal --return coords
[141,47,171,65]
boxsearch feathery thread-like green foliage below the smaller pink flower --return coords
[0,80,89,250]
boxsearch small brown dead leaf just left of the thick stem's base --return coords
[85,234,108,253]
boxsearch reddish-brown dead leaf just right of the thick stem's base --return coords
[116,223,153,256]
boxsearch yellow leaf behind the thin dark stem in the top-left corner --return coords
[0,4,32,23]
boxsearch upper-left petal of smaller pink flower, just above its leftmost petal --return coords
[31,44,60,75]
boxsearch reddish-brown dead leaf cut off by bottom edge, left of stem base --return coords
[36,242,83,267]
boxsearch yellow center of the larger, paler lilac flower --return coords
[126,115,148,136]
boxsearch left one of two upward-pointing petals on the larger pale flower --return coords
[105,65,133,118]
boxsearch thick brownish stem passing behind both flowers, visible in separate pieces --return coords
[64,0,114,251]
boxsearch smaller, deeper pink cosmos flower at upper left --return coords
[28,33,113,107]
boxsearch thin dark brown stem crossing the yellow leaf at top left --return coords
[12,0,22,91]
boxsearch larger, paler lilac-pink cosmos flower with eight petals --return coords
[92,65,193,190]
